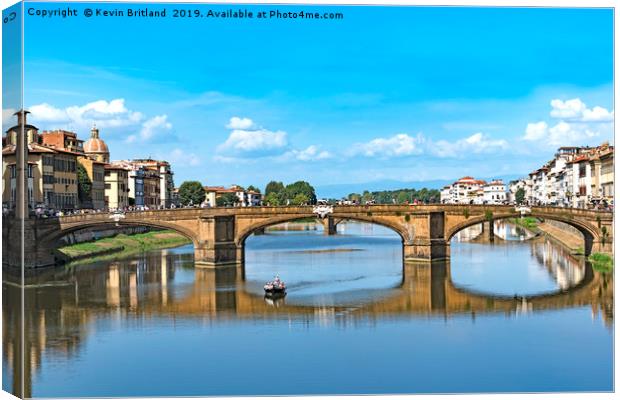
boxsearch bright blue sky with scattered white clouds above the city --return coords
[3,3,614,191]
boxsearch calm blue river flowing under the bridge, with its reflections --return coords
[2,223,613,397]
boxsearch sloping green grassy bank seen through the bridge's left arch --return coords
[58,230,191,262]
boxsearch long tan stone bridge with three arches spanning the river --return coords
[3,205,613,267]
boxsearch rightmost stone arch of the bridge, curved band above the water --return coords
[446,212,599,255]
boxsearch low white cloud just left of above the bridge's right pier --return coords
[349,133,424,158]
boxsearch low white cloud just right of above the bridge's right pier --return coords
[428,132,509,158]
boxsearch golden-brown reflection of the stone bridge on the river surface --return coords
[3,240,613,397]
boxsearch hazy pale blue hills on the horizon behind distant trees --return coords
[315,175,520,199]
